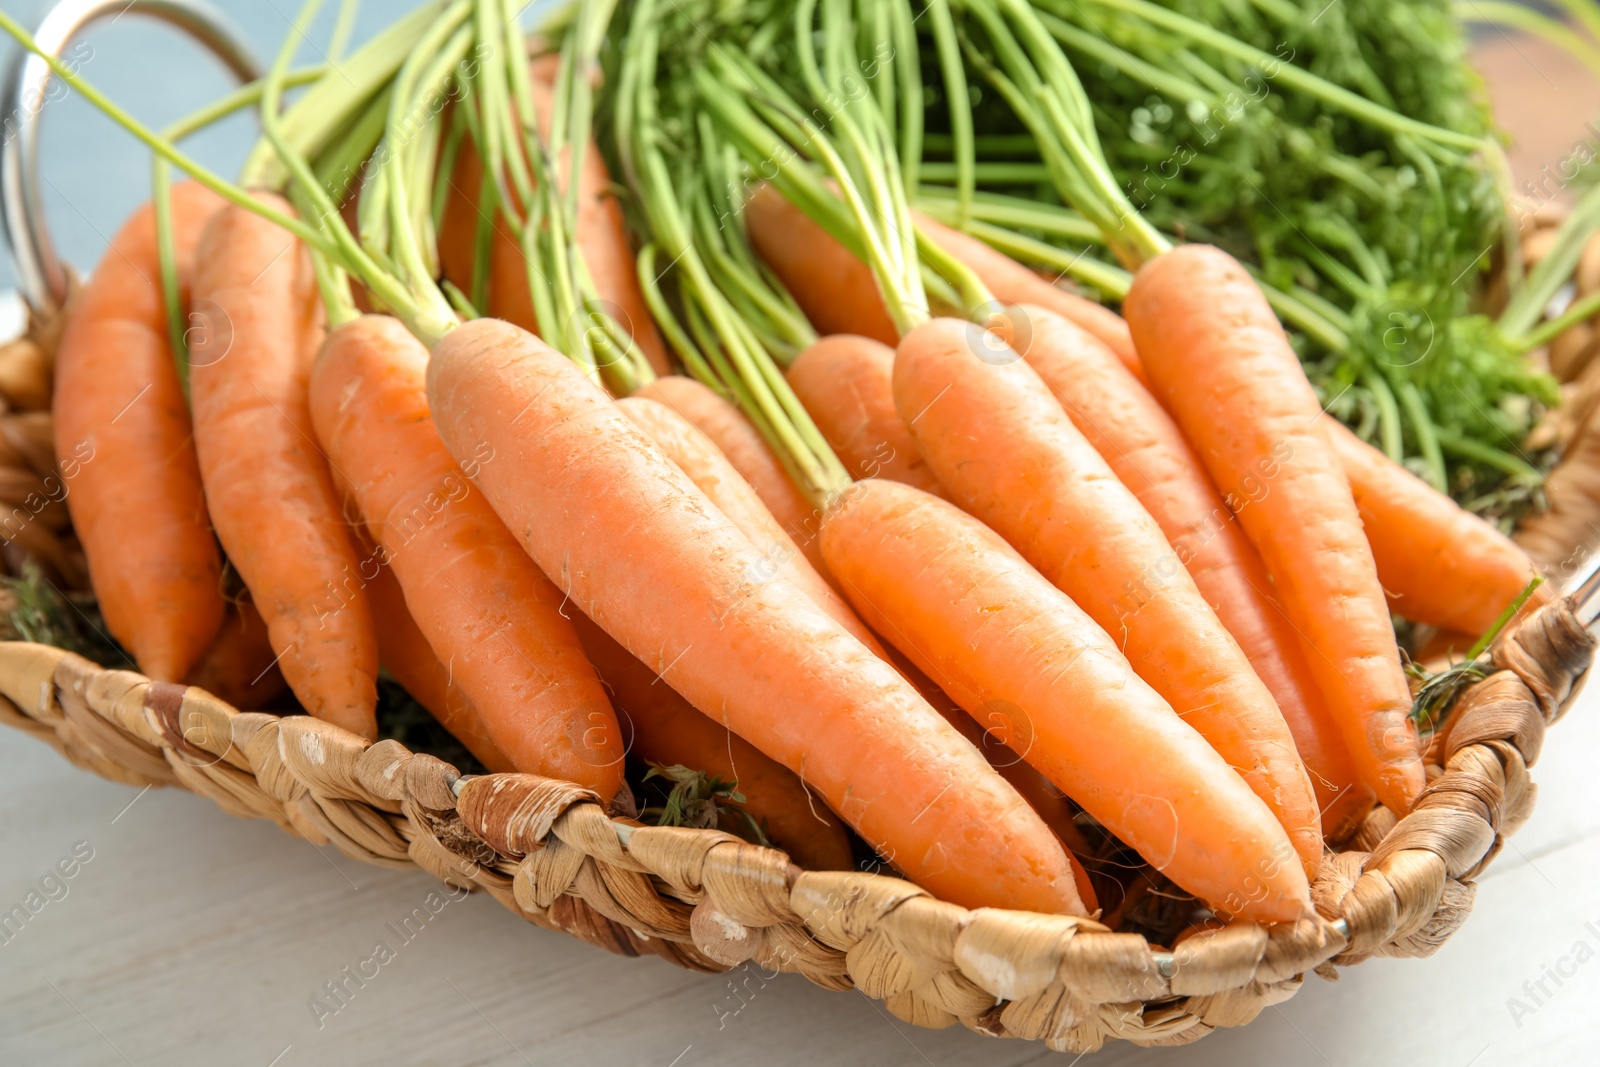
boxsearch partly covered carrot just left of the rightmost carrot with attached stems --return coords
[997,306,1373,840]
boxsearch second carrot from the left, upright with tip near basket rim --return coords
[190,194,378,739]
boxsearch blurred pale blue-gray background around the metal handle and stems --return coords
[0,0,547,290]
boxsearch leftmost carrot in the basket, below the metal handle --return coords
[54,182,226,681]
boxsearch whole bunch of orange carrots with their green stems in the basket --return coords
[0,0,1550,923]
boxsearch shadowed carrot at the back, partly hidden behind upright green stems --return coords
[438,62,670,374]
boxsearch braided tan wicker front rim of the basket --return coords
[0,603,1595,1051]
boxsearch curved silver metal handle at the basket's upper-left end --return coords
[0,0,261,312]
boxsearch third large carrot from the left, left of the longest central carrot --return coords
[310,315,624,801]
